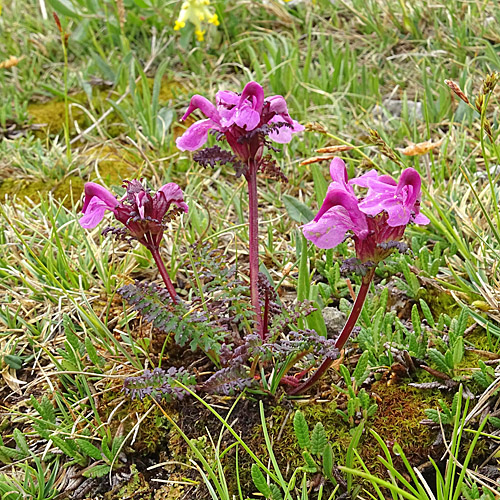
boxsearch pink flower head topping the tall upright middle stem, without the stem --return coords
[176,82,304,161]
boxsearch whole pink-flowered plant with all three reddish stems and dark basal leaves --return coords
[80,82,429,394]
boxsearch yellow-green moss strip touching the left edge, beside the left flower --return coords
[0,176,84,208]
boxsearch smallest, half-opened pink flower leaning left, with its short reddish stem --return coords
[80,180,188,302]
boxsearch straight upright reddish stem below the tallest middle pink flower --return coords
[245,159,264,338]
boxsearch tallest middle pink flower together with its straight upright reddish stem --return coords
[177,82,304,338]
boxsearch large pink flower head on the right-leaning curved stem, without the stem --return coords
[302,158,429,263]
